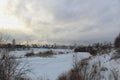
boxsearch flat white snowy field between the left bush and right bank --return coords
[10,49,90,80]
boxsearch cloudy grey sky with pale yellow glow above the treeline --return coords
[0,0,120,44]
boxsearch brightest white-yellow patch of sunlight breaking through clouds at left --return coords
[0,0,23,30]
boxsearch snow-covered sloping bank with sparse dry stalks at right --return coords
[84,50,120,80]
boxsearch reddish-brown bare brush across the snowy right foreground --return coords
[57,52,120,80]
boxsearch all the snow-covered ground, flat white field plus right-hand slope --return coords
[3,49,120,80]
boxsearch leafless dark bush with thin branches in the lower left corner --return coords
[0,50,30,80]
